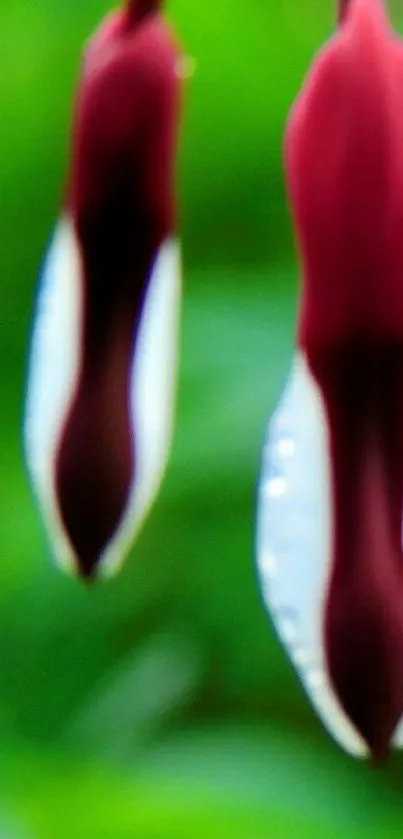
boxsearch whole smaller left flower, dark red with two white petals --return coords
[26,0,186,577]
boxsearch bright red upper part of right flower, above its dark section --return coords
[287,0,403,346]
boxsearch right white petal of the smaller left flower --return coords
[99,240,181,576]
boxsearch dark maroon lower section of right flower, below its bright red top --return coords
[311,342,403,758]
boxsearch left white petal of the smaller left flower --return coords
[24,213,82,571]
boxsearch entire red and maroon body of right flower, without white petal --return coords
[287,0,403,757]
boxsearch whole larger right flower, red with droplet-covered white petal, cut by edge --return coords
[258,0,403,759]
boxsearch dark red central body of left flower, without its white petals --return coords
[56,14,179,576]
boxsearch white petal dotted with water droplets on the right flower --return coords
[257,356,367,756]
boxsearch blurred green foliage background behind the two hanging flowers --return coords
[0,0,403,839]
